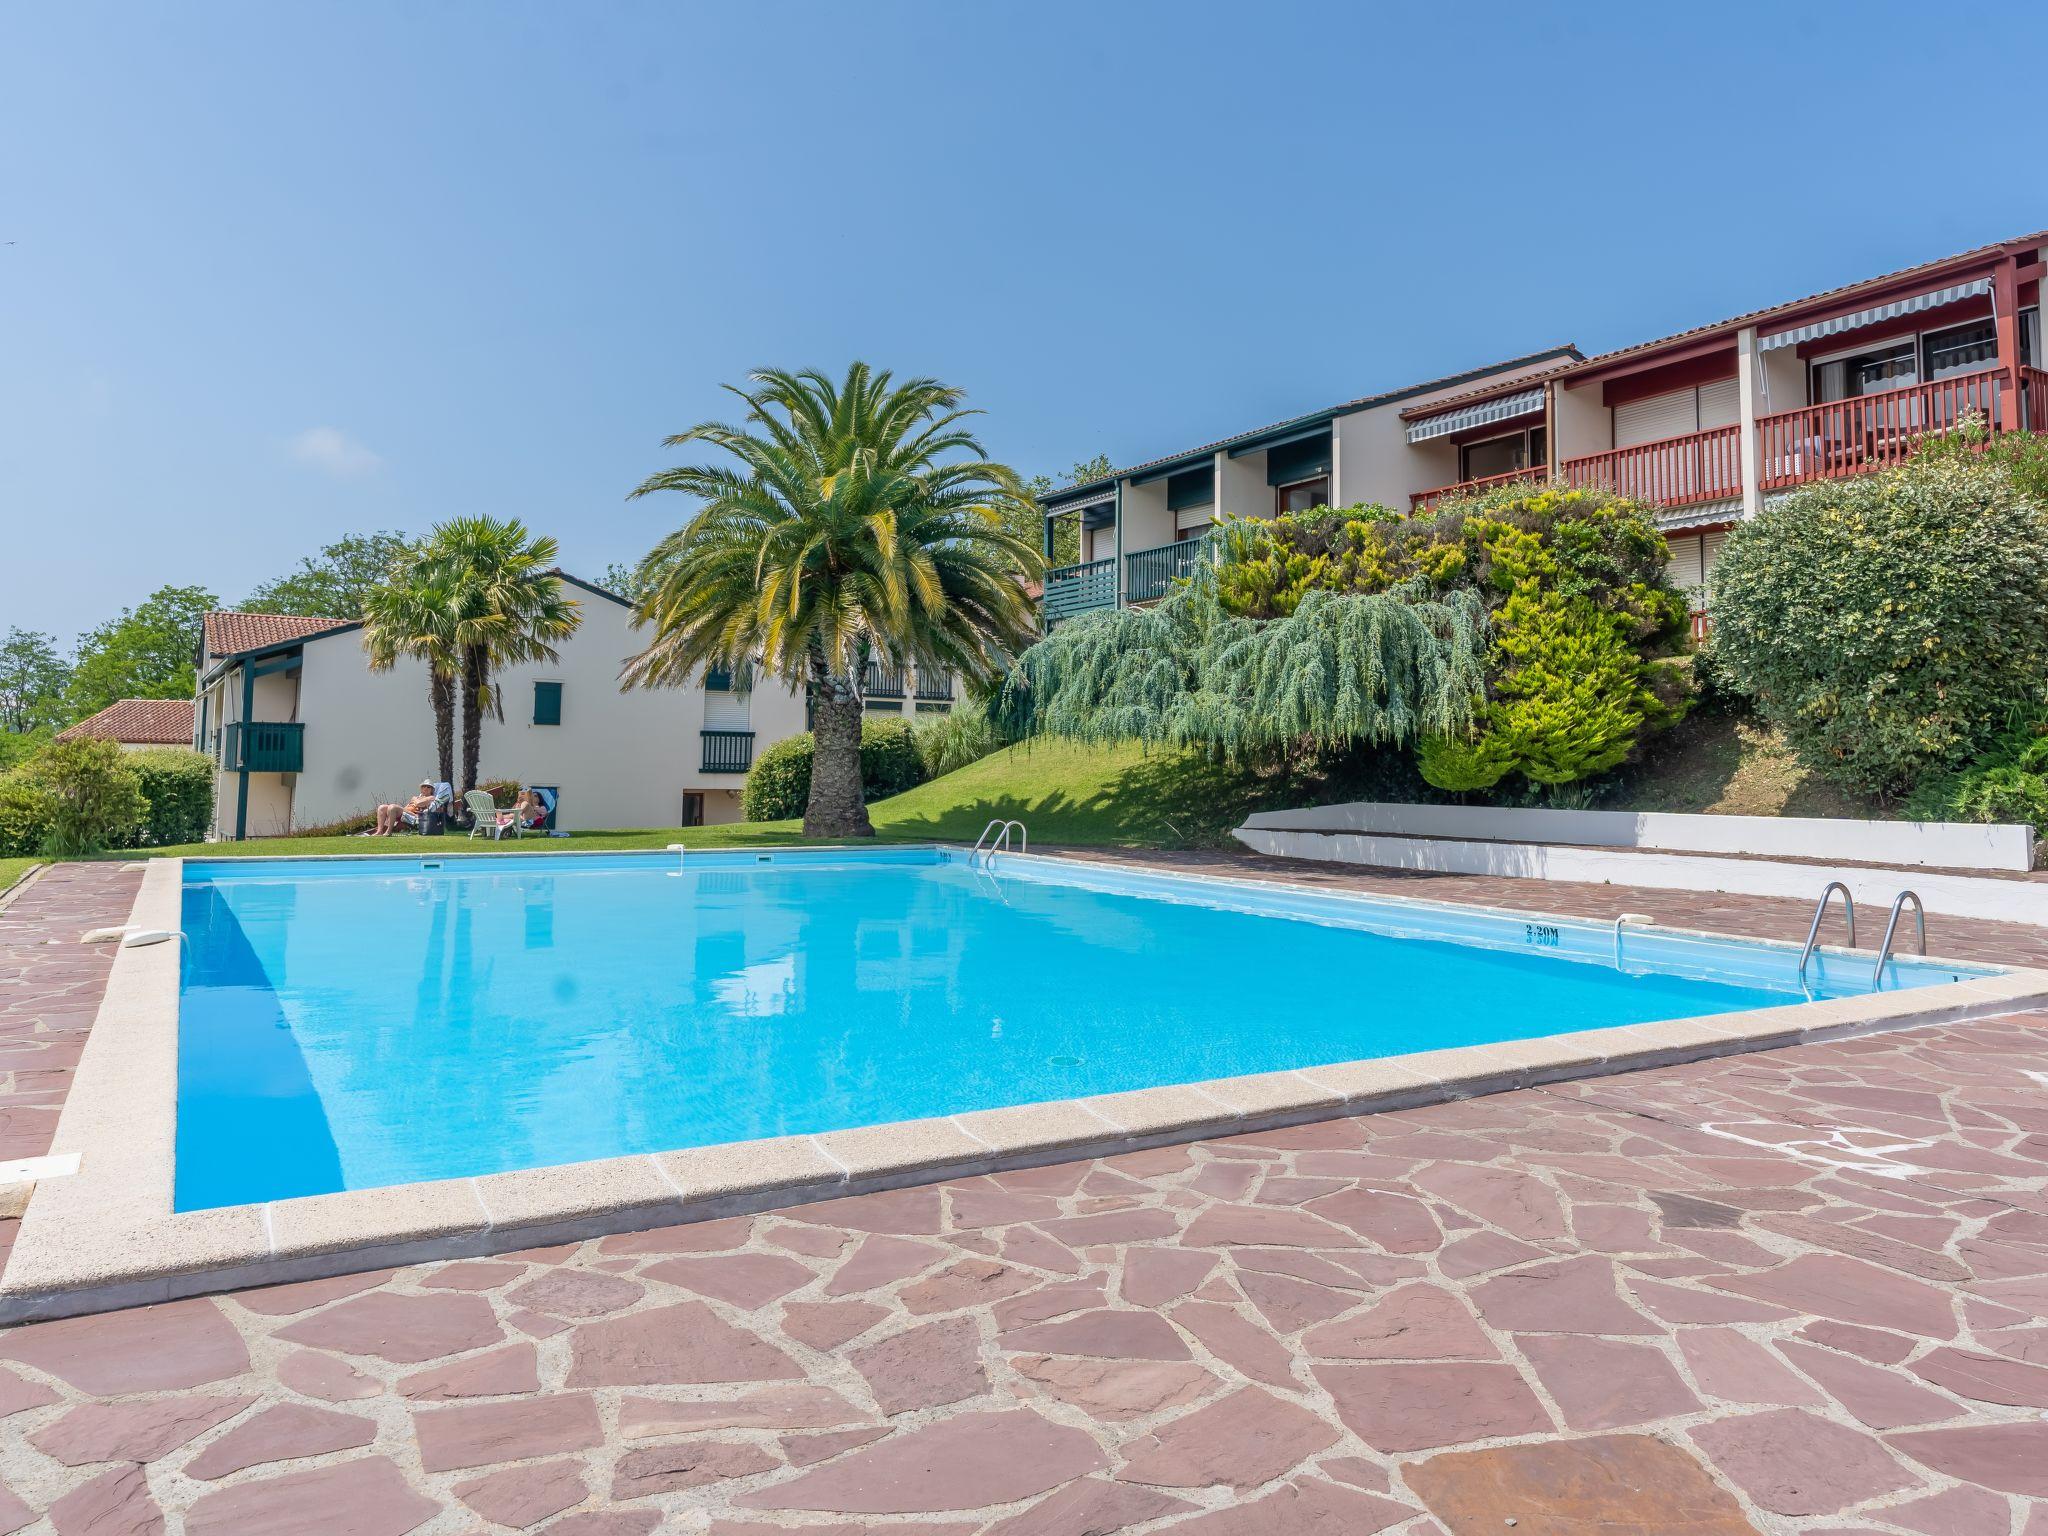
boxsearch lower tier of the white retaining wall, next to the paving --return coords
[1233,821,2048,925]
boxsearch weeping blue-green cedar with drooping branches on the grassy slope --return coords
[1001,565,1487,760]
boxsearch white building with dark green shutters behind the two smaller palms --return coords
[190,575,864,838]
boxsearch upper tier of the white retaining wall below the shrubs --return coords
[1245,801,2034,870]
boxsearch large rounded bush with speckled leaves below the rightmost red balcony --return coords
[1714,455,2048,797]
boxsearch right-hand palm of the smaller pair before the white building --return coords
[424,516,584,791]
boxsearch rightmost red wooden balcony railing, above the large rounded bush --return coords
[1757,369,2007,489]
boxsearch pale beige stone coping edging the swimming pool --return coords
[0,844,2048,1323]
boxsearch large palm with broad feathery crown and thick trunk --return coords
[623,362,1040,838]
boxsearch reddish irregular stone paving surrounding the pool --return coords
[0,860,2048,1536]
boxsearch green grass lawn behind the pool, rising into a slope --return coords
[99,741,1257,868]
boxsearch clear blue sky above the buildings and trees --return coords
[0,0,2048,641]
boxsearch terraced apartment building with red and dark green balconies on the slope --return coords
[1044,231,2048,633]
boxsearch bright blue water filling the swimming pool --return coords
[176,848,1982,1210]
